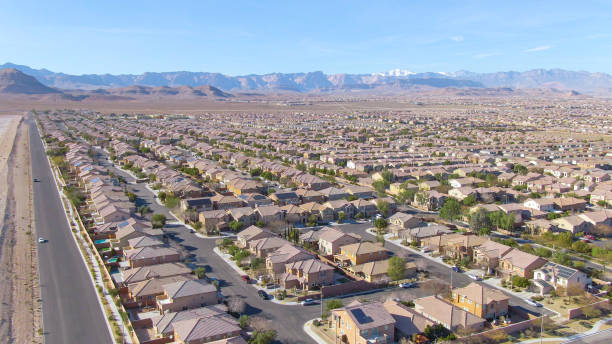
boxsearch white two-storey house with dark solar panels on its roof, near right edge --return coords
[533,262,591,295]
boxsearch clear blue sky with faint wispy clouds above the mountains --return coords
[0,0,612,75]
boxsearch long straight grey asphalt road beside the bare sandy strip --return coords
[28,118,112,344]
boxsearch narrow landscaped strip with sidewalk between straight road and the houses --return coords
[39,121,137,343]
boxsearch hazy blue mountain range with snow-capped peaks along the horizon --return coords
[0,63,612,97]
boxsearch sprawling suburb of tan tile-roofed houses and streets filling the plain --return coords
[27,98,612,344]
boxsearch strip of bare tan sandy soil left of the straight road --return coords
[0,117,42,343]
